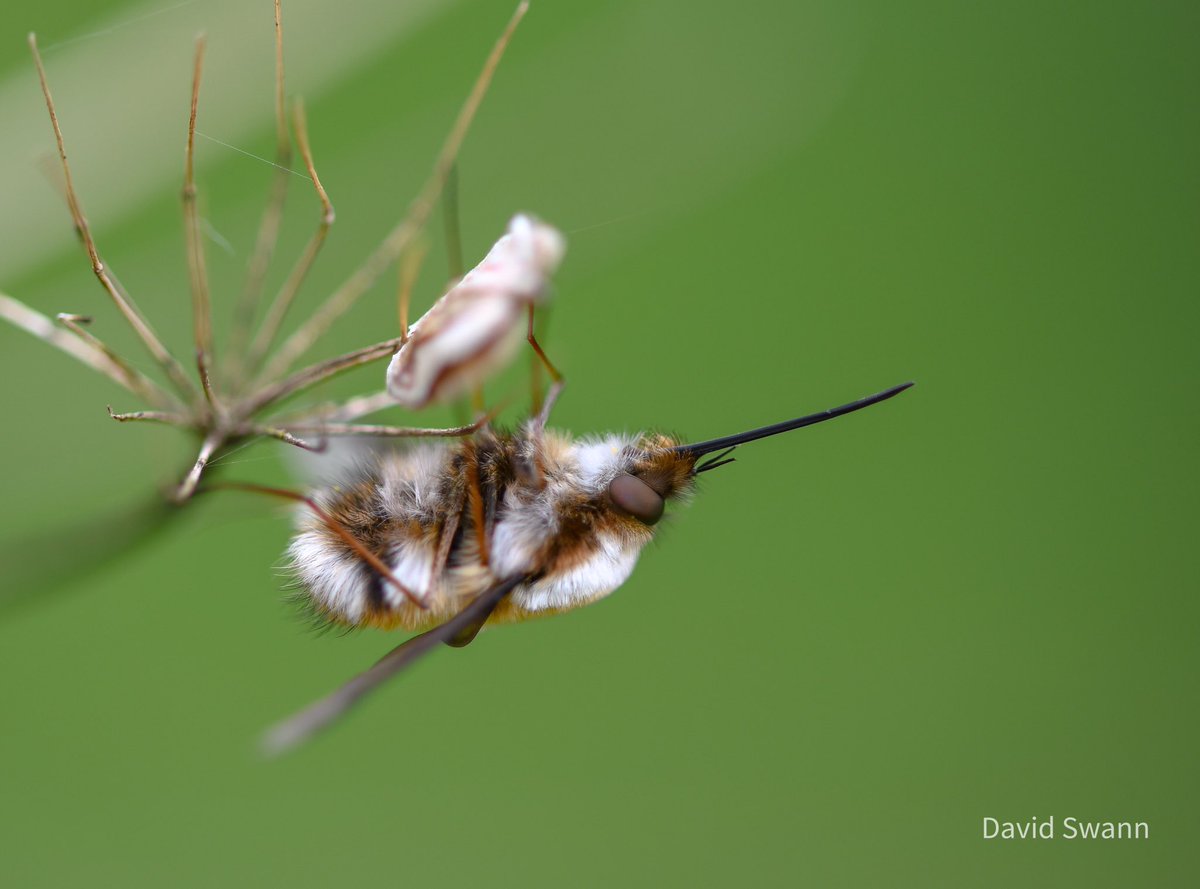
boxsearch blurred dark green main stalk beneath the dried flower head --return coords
[0,497,182,611]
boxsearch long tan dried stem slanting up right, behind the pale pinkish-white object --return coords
[263,0,529,379]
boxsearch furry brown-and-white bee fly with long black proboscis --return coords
[272,383,912,752]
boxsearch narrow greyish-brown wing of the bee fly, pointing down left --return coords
[263,576,529,756]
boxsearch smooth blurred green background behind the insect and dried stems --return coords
[0,0,1200,887]
